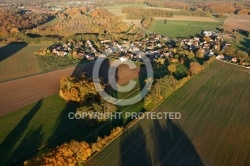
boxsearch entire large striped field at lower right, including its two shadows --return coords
[86,61,250,166]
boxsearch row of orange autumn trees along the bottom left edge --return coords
[24,127,123,166]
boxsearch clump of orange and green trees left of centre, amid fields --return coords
[59,75,117,125]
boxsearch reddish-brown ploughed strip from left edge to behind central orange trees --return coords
[0,62,141,116]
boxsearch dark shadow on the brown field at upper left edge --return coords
[0,42,28,62]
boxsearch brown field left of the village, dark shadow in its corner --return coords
[0,44,48,81]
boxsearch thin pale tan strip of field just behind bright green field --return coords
[155,15,219,22]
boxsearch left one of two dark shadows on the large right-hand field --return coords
[119,126,152,166]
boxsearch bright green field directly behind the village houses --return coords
[149,20,221,38]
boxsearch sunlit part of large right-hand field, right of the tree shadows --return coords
[157,61,250,165]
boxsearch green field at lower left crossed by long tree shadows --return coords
[0,95,79,165]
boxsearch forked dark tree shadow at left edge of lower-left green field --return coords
[0,100,43,165]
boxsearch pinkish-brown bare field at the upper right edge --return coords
[224,15,250,31]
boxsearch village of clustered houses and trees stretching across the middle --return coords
[35,31,249,66]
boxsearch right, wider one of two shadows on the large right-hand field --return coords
[152,119,204,166]
